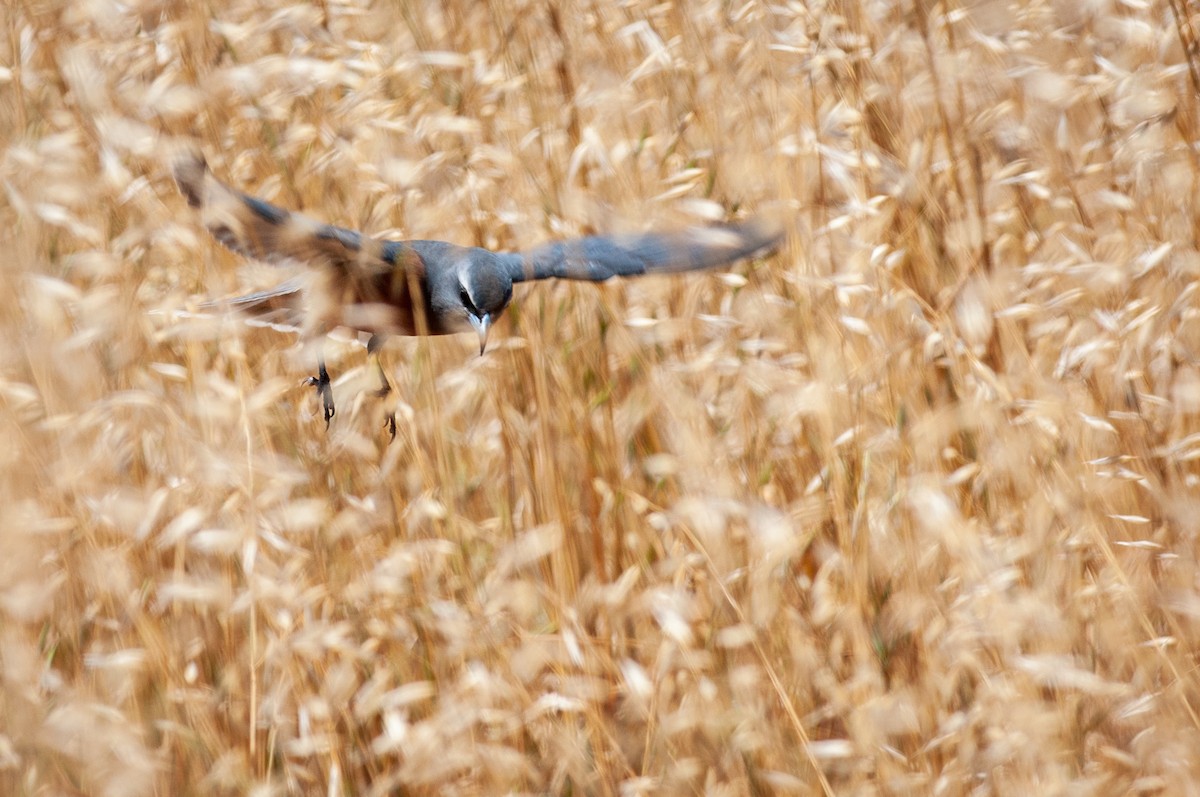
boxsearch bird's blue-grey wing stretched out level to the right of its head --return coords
[502,221,784,282]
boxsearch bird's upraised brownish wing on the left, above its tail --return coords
[174,154,410,275]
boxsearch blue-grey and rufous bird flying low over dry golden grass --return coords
[174,152,782,438]
